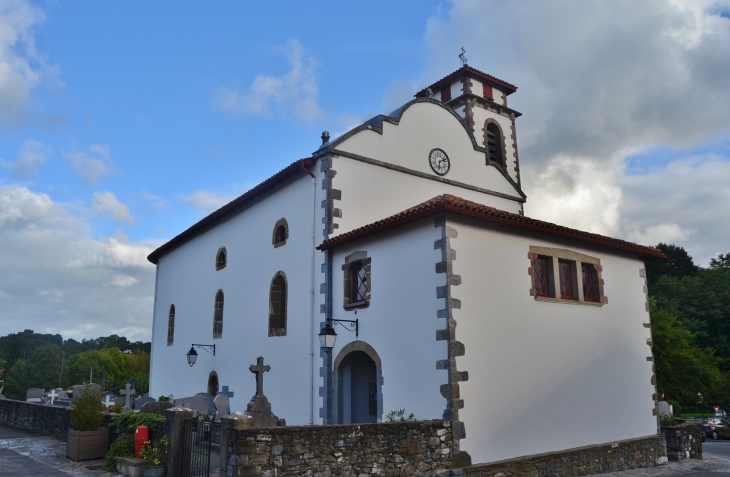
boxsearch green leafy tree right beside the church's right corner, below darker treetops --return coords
[650,299,726,406]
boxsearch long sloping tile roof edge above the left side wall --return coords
[147,158,315,264]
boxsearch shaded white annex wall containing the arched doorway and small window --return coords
[332,218,448,419]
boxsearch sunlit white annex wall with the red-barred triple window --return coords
[448,217,656,463]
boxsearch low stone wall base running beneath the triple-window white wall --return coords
[463,434,667,477]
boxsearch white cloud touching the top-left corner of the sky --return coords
[0,0,56,128]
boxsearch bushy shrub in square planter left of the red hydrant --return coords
[66,385,109,462]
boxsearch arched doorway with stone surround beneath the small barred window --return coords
[332,341,383,424]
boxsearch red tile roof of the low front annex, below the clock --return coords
[317,194,667,258]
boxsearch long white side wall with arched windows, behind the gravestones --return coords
[150,175,322,424]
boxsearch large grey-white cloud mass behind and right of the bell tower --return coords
[420,0,730,262]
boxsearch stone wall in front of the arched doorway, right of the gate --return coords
[228,421,453,477]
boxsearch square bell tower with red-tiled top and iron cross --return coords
[415,64,522,185]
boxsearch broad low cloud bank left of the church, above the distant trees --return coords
[0,185,159,340]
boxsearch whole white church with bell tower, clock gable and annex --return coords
[148,65,663,463]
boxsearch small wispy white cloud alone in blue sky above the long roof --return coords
[215,39,324,124]
